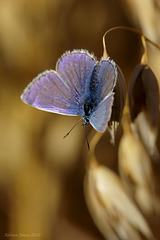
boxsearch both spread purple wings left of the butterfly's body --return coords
[21,50,95,115]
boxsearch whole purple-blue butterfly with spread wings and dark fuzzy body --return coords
[21,50,118,132]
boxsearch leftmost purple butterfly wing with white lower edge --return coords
[21,70,80,115]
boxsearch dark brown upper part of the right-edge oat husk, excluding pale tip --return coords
[128,64,159,129]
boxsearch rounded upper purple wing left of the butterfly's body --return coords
[56,50,96,104]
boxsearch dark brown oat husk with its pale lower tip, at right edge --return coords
[128,64,159,158]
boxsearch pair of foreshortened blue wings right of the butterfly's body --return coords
[90,58,118,132]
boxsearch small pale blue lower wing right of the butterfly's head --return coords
[90,92,114,132]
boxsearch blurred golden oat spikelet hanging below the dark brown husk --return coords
[118,128,158,214]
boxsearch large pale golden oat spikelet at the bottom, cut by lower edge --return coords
[84,165,153,240]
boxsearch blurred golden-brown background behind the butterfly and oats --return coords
[0,0,160,240]
